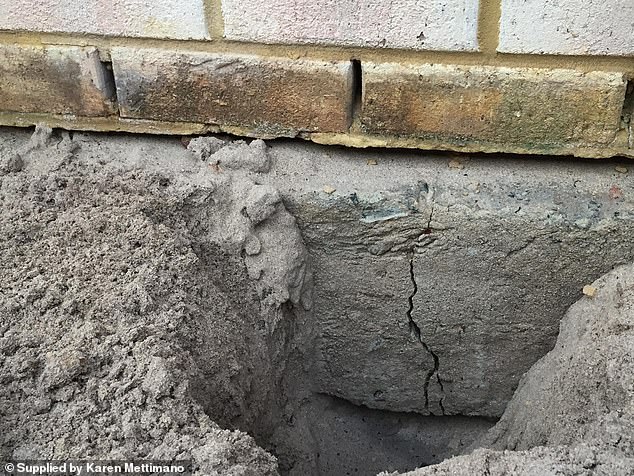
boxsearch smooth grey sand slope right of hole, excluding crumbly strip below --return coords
[483,265,634,456]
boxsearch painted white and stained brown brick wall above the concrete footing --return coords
[0,0,634,157]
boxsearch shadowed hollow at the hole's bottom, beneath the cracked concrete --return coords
[261,394,495,476]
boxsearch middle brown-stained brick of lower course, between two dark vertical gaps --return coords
[111,48,352,135]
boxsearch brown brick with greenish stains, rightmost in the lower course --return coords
[361,64,626,151]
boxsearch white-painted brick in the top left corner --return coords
[0,0,209,40]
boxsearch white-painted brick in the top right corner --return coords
[498,0,634,56]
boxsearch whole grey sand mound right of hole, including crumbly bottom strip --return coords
[386,264,634,476]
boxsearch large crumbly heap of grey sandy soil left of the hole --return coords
[0,128,310,475]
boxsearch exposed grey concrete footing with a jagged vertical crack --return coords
[254,143,634,417]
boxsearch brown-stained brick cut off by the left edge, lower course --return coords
[0,45,114,116]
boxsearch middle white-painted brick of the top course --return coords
[222,0,478,51]
